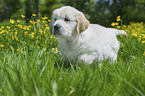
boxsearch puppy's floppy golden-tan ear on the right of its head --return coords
[77,12,90,34]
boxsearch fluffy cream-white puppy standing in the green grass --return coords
[50,6,127,64]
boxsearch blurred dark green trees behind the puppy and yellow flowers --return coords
[0,0,145,27]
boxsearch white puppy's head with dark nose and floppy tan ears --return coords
[50,6,89,37]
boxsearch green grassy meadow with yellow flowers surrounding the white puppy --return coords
[0,14,145,96]
